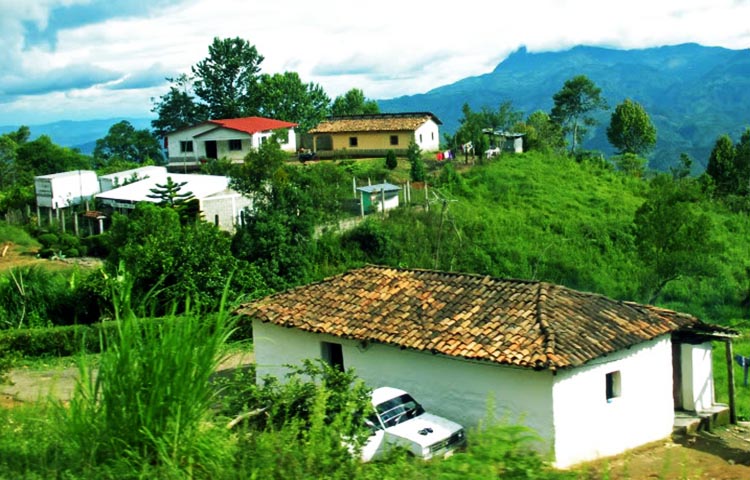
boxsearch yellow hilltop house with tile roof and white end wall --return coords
[308,112,442,156]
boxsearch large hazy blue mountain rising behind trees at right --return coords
[378,44,750,170]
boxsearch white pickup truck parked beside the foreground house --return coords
[362,387,466,461]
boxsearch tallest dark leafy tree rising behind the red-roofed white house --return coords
[192,37,264,119]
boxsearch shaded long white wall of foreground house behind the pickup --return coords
[253,320,553,451]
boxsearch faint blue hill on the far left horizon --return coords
[0,117,151,154]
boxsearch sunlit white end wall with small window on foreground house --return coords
[553,335,674,467]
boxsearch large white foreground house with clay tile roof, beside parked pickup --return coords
[237,266,736,467]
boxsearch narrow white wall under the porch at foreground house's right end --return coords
[680,342,714,412]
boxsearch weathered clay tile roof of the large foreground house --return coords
[237,266,736,370]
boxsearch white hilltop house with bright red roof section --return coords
[165,117,297,168]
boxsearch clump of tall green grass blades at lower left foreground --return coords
[59,286,232,478]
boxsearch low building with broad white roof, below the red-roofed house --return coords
[96,172,252,232]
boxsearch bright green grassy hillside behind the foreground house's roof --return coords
[334,153,750,323]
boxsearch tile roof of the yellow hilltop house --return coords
[308,112,441,133]
